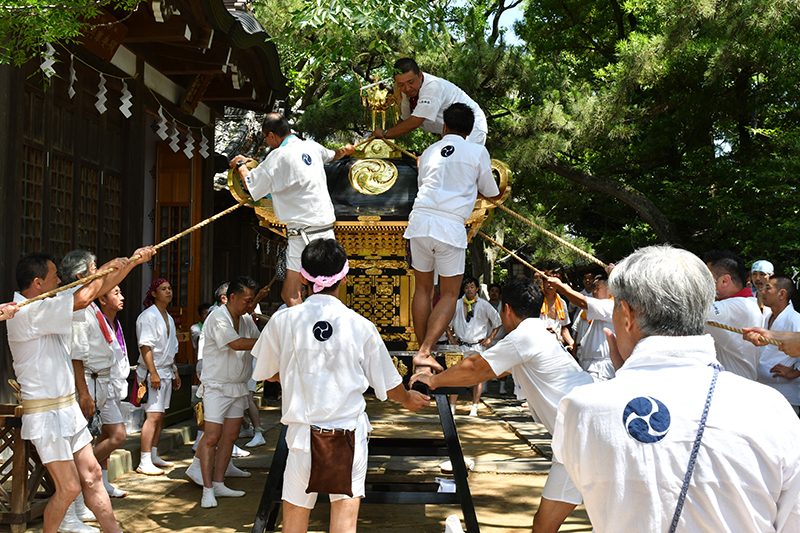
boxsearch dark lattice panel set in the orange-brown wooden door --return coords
[158,205,192,307]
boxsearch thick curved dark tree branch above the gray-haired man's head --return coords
[545,157,681,244]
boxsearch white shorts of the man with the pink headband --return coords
[283,428,368,509]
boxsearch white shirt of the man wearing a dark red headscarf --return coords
[136,305,178,382]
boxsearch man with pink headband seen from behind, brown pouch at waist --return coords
[252,239,430,531]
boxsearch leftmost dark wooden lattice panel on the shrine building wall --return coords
[20,145,44,254]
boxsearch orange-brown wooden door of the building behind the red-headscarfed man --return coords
[153,143,202,363]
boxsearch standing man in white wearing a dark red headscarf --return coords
[136,278,181,476]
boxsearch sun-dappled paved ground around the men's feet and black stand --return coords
[7,383,592,533]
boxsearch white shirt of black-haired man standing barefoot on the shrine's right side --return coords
[403,134,500,248]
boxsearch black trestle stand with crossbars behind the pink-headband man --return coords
[252,388,480,533]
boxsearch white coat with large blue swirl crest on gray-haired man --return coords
[553,335,800,533]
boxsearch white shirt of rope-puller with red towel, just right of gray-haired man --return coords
[706,297,764,381]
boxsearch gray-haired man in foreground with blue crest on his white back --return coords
[553,246,800,532]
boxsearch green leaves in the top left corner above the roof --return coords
[0,0,140,66]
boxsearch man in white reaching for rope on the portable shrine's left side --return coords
[230,113,355,307]
